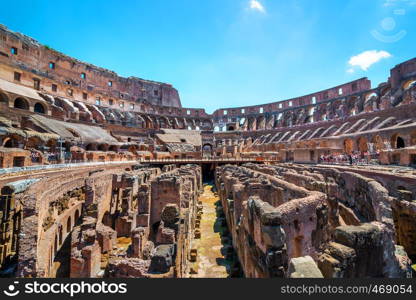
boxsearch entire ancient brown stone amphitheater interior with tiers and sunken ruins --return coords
[0,26,416,278]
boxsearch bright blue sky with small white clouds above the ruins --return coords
[0,0,416,113]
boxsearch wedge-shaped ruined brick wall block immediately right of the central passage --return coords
[216,166,328,278]
